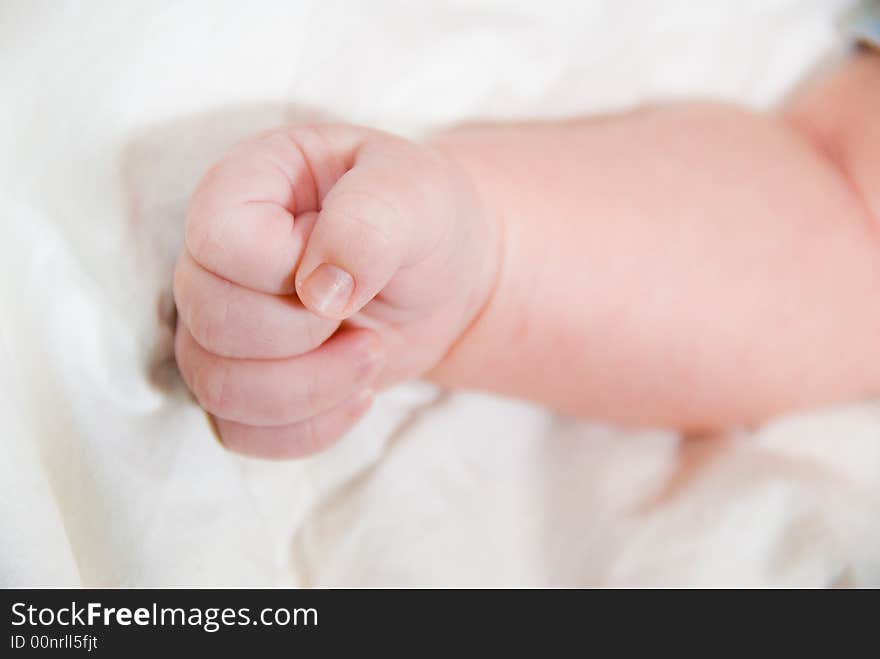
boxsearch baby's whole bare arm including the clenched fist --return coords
[174,52,880,458]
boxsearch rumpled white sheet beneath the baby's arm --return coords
[0,0,880,586]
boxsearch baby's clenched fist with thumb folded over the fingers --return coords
[174,125,495,458]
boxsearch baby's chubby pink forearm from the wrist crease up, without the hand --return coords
[431,52,880,431]
